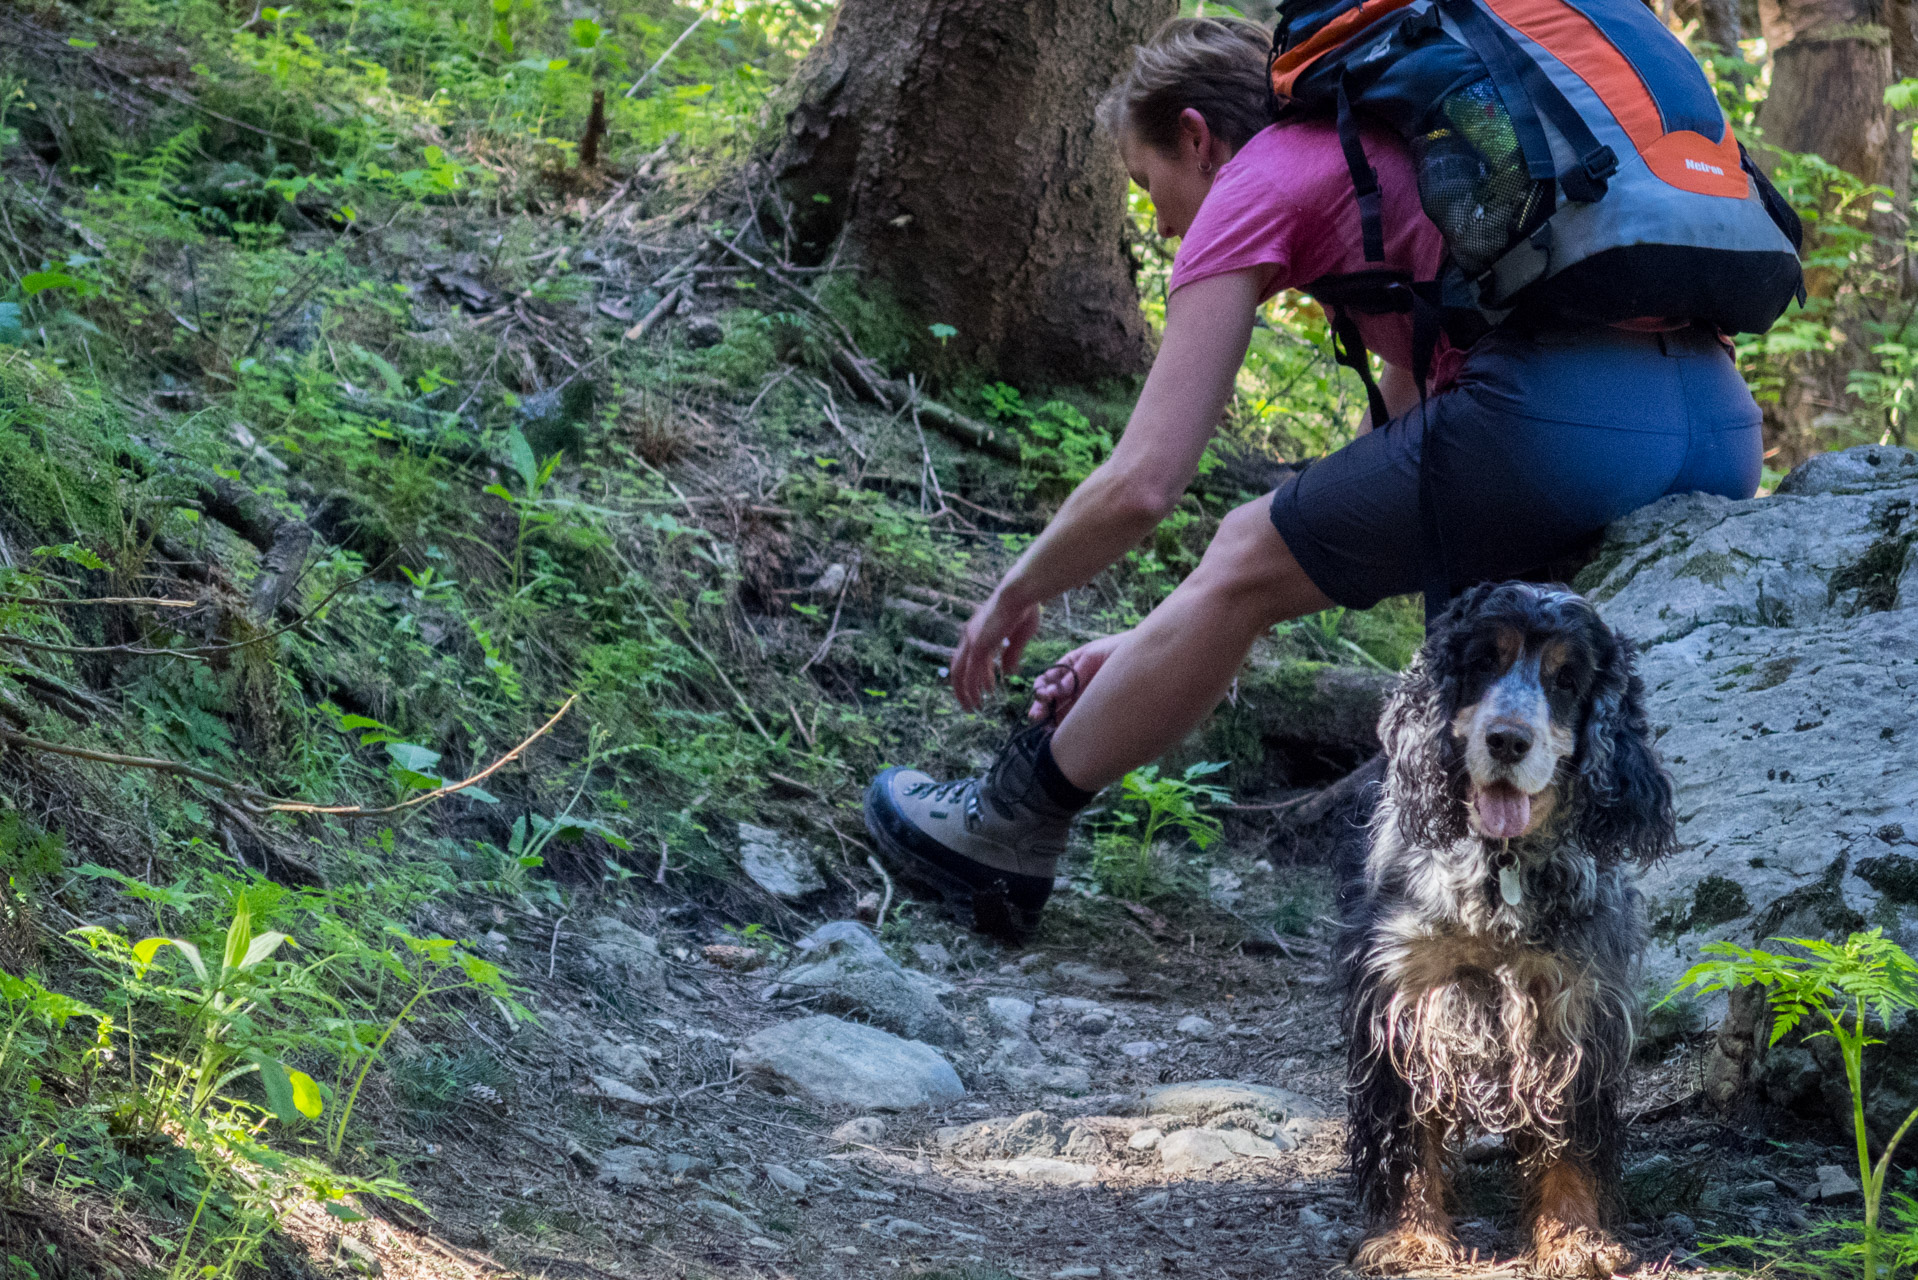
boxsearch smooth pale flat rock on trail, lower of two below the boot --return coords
[733,1013,965,1111]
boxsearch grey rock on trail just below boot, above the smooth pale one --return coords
[763,921,965,1046]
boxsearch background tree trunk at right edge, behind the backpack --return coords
[1757,0,1918,468]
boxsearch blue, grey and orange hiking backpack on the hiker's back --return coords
[1270,0,1805,422]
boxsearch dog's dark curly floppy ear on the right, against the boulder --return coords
[1579,626,1676,865]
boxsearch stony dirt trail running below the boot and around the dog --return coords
[316,852,1809,1280]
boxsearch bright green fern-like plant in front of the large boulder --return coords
[1661,929,1918,1280]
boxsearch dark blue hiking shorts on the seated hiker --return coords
[1272,328,1765,608]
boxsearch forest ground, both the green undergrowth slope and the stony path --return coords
[0,0,1871,1280]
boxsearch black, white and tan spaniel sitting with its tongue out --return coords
[1339,581,1674,1276]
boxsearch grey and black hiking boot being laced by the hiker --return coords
[865,725,1078,942]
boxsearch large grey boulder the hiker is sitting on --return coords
[1579,447,1918,997]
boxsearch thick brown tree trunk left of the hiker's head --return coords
[773,0,1178,384]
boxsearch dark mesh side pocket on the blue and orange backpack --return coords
[1412,79,1546,276]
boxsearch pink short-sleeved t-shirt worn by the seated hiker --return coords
[1172,121,1456,384]
